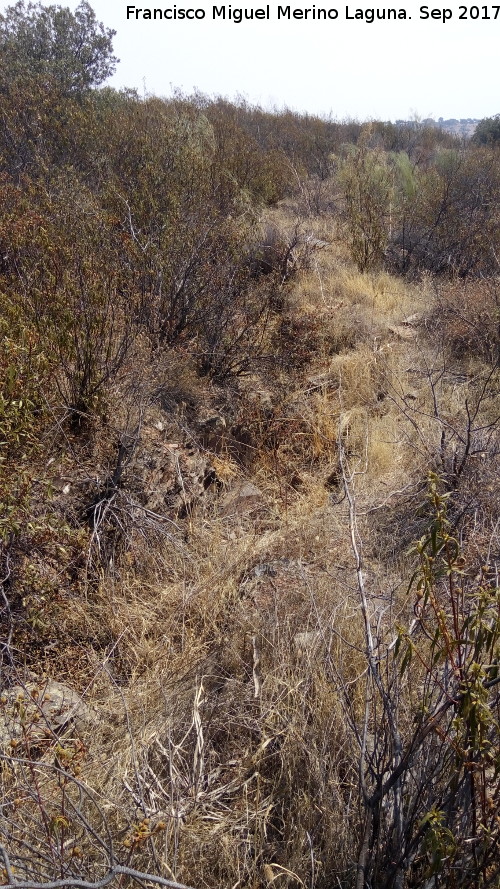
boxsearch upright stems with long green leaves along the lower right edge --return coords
[400,475,500,887]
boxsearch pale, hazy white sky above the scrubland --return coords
[0,0,500,120]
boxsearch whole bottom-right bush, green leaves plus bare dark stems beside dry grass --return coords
[346,475,500,889]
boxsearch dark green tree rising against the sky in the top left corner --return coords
[0,0,119,93]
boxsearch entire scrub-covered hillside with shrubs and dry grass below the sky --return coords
[0,2,500,889]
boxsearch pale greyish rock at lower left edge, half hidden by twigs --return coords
[0,679,96,747]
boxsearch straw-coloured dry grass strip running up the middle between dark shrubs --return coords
[70,238,428,887]
